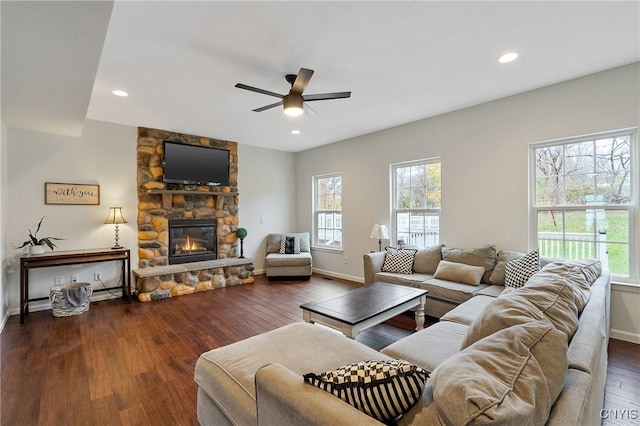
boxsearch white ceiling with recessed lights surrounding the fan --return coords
[1,0,640,152]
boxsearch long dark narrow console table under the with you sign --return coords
[20,248,131,324]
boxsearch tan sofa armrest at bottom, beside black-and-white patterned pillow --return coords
[256,364,382,426]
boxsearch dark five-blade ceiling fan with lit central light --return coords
[235,68,351,117]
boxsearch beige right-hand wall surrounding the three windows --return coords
[296,63,640,342]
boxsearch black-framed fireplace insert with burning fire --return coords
[169,219,217,265]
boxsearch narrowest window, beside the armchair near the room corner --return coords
[313,174,342,249]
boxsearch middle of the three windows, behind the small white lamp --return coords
[391,159,442,248]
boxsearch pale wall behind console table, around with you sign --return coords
[3,121,138,314]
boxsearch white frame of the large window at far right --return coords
[528,127,640,284]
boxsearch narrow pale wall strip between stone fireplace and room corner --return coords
[238,144,296,273]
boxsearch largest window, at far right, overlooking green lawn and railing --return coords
[530,130,638,278]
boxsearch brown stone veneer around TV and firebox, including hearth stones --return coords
[136,127,253,300]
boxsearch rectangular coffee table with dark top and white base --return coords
[300,282,428,339]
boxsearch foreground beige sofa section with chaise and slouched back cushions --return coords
[195,255,610,426]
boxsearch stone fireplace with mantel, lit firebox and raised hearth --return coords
[133,127,253,301]
